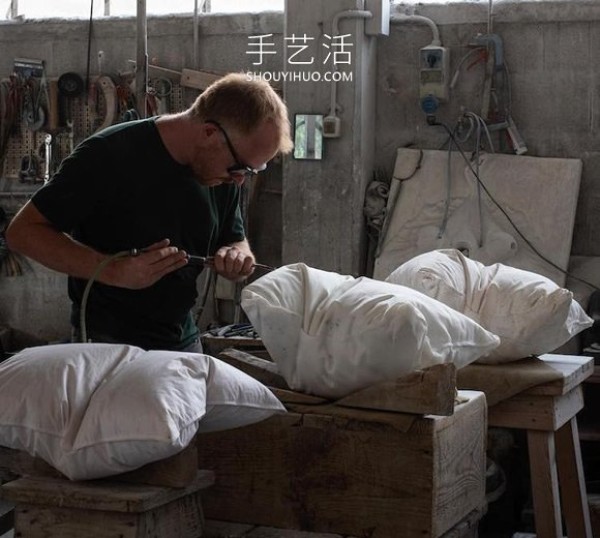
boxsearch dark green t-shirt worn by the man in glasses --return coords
[32,118,245,349]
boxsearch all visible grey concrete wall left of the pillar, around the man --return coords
[0,13,283,340]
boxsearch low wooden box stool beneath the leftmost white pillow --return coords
[0,471,214,538]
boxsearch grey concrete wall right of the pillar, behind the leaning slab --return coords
[376,0,600,256]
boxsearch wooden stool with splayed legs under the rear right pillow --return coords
[488,355,594,538]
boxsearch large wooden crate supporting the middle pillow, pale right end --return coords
[198,391,486,538]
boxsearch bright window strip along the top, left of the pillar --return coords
[0,0,284,19]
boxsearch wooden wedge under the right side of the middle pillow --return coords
[335,364,456,416]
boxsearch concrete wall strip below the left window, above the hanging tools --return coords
[0,13,283,76]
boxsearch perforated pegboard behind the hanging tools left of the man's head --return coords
[2,79,186,185]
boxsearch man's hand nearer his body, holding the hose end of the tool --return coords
[99,239,187,290]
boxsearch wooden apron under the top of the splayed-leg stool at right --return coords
[488,386,583,432]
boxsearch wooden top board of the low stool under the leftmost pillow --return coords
[0,471,214,512]
